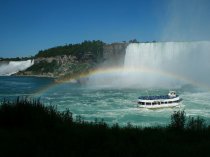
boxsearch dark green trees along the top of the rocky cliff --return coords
[35,40,104,61]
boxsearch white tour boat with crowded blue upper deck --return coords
[138,91,182,109]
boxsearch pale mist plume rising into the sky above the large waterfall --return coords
[162,0,210,41]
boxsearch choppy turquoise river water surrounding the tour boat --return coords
[0,76,210,126]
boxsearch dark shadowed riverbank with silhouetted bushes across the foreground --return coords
[0,99,210,157]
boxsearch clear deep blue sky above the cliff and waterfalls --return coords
[0,0,210,57]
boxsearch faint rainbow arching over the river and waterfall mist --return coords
[33,67,210,95]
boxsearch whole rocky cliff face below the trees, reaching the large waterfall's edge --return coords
[17,43,128,79]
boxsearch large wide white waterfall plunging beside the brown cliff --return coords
[124,41,210,86]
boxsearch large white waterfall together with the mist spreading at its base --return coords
[87,41,210,89]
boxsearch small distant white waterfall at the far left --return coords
[0,60,34,76]
